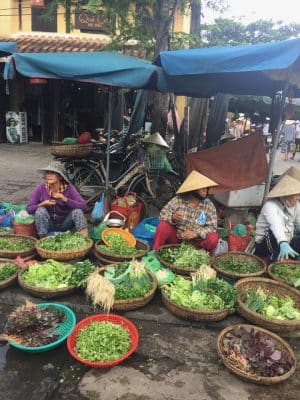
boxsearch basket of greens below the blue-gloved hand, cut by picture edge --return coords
[268,260,300,290]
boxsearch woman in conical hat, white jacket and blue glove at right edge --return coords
[255,171,300,261]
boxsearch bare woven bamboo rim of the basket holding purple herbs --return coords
[217,324,297,385]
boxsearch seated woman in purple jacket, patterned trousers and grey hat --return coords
[27,161,88,237]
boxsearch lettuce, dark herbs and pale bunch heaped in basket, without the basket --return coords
[163,268,237,312]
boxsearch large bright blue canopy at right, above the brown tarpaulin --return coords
[156,39,300,97]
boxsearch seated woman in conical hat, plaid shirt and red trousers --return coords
[153,171,219,253]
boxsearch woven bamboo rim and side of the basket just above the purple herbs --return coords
[234,278,300,329]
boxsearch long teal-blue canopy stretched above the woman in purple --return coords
[4,51,161,88]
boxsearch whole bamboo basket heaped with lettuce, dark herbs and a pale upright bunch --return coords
[161,265,236,321]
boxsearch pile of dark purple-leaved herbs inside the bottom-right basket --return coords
[222,327,293,377]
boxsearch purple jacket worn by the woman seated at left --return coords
[27,183,87,223]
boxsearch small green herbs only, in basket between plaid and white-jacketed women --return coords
[216,254,261,274]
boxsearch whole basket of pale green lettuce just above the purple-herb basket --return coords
[234,278,300,334]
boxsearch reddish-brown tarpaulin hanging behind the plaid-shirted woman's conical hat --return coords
[186,133,268,193]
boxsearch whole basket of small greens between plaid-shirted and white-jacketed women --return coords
[211,251,266,279]
